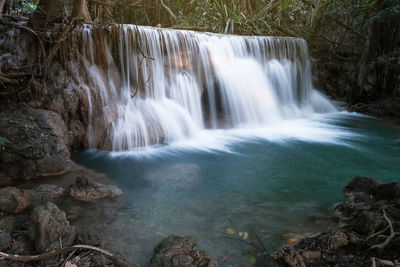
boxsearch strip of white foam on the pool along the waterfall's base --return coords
[106,112,363,158]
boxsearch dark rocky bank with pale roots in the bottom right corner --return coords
[273,177,400,267]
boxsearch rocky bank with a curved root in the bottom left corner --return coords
[0,176,135,267]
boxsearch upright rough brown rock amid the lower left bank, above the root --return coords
[29,202,76,252]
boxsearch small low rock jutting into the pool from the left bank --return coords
[70,175,122,203]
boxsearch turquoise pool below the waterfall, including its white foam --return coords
[73,113,400,266]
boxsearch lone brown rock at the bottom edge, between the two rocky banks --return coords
[149,235,218,267]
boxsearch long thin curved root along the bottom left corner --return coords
[0,245,133,267]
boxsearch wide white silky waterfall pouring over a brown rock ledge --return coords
[76,25,335,150]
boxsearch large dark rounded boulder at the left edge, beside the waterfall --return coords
[0,105,71,180]
